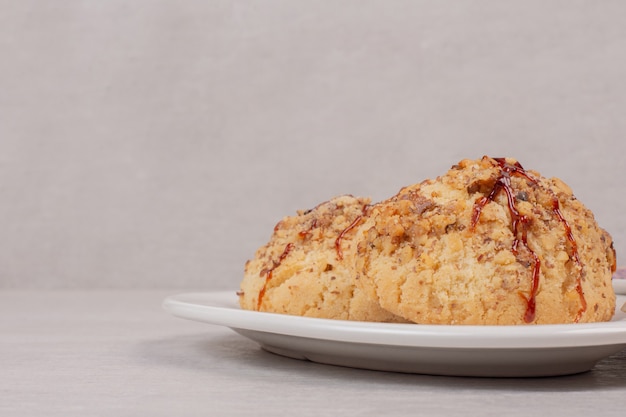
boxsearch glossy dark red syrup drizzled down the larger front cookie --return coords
[471,158,587,323]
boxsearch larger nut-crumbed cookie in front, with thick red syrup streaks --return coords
[354,157,615,325]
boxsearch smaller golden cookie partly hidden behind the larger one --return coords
[239,195,405,322]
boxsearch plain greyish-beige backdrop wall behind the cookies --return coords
[0,0,626,289]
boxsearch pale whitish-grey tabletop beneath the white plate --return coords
[0,290,626,417]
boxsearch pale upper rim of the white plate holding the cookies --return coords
[162,290,626,349]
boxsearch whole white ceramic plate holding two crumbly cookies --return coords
[163,291,626,377]
